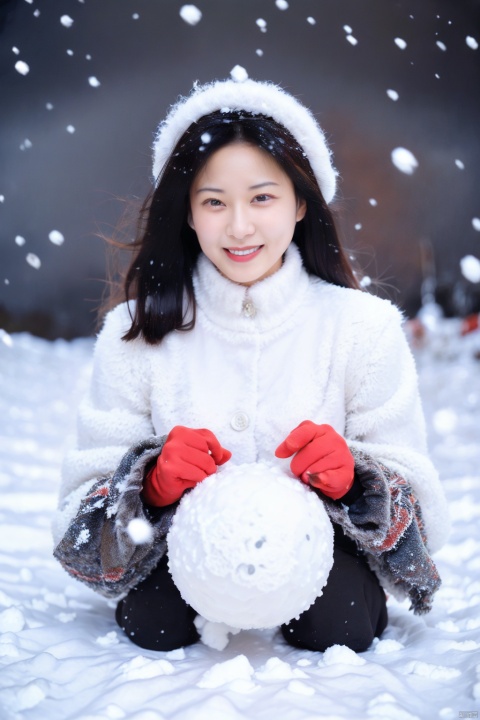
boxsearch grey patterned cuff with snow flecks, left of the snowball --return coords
[54,437,176,597]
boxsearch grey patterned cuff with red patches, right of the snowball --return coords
[323,451,440,614]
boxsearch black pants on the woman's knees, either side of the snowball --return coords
[115,543,387,652]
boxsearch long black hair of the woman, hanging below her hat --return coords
[123,111,359,344]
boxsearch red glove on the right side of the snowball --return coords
[275,420,355,500]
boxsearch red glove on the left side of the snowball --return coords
[143,425,232,507]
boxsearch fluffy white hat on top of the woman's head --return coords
[153,79,337,203]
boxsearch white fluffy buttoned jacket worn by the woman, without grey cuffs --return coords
[54,244,448,551]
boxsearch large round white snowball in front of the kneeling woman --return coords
[168,463,333,629]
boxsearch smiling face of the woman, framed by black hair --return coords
[189,142,306,285]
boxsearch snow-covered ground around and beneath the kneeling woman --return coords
[0,321,480,720]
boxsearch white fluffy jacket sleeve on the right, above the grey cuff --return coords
[346,298,449,552]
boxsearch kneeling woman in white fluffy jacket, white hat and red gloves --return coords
[55,80,447,651]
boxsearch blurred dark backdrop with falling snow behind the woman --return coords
[0,0,480,338]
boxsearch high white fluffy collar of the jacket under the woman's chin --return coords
[193,243,309,333]
